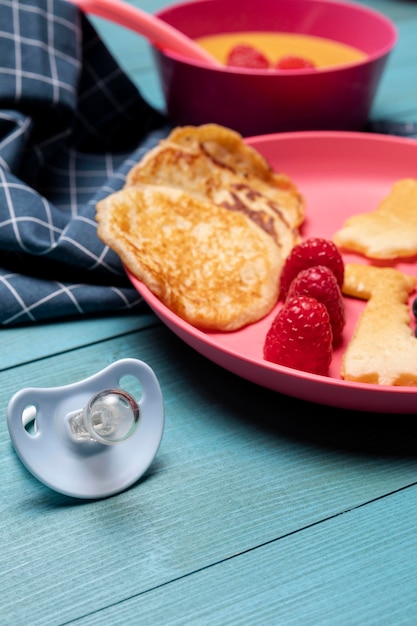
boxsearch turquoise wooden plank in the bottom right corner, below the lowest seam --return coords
[68,487,417,626]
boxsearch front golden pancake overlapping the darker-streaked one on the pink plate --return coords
[96,185,283,331]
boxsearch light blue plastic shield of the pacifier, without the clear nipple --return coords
[7,359,164,499]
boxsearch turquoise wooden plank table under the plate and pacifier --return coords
[0,0,417,626]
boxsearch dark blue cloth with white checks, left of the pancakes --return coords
[0,0,169,326]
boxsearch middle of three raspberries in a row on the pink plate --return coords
[287,265,346,343]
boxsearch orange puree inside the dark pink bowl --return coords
[196,32,366,67]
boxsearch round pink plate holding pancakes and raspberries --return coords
[128,131,417,413]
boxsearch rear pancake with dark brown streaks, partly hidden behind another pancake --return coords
[125,124,305,258]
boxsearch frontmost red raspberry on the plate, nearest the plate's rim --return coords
[264,296,333,376]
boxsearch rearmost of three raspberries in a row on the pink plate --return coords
[280,237,345,301]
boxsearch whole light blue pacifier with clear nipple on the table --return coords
[7,359,164,499]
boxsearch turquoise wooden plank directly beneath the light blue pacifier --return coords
[0,326,416,626]
